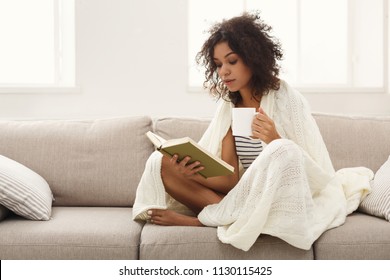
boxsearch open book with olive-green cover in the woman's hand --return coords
[146,131,234,178]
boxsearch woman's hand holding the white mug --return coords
[252,107,281,144]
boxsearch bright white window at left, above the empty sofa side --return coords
[0,0,75,88]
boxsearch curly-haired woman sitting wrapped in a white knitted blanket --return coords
[134,13,372,250]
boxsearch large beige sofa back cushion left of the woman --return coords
[0,117,153,207]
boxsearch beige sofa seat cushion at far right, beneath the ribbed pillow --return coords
[314,212,390,260]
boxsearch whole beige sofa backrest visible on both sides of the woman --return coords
[0,114,390,207]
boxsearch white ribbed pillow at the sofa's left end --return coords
[0,155,53,220]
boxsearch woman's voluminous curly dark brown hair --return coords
[196,12,283,104]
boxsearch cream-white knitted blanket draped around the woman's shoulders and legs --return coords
[133,81,373,251]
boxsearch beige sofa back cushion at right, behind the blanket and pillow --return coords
[313,113,390,172]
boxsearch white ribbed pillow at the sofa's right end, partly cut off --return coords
[359,156,390,222]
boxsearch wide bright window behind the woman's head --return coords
[188,0,388,92]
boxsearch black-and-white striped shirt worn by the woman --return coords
[234,136,263,170]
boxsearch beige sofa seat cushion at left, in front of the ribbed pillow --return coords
[0,207,142,260]
